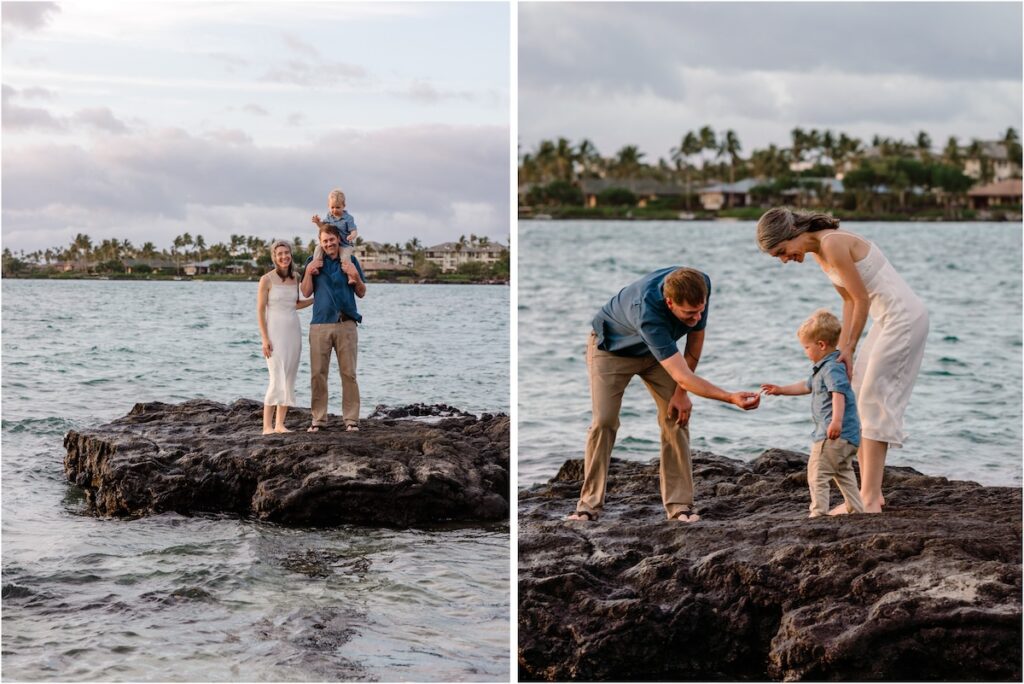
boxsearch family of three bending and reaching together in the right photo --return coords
[569,208,929,522]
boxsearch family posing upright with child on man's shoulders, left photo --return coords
[256,190,367,434]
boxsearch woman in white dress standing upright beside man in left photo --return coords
[256,240,313,434]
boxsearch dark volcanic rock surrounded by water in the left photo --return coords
[65,399,509,525]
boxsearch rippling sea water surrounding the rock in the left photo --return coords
[0,281,510,681]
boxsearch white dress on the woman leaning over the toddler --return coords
[822,232,928,447]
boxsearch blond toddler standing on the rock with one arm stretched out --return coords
[761,309,864,518]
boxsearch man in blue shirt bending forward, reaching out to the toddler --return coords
[569,267,761,522]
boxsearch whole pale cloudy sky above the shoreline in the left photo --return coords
[0,1,511,252]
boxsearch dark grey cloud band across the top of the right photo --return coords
[519,2,1022,97]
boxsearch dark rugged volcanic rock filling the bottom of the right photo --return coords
[519,450,1022,681]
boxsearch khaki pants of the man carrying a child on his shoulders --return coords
[309,320,359,426]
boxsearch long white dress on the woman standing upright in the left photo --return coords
[263,283,302,407]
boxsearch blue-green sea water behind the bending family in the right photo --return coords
[517,221,1022,486]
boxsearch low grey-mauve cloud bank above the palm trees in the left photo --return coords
[2,126,509,250]
